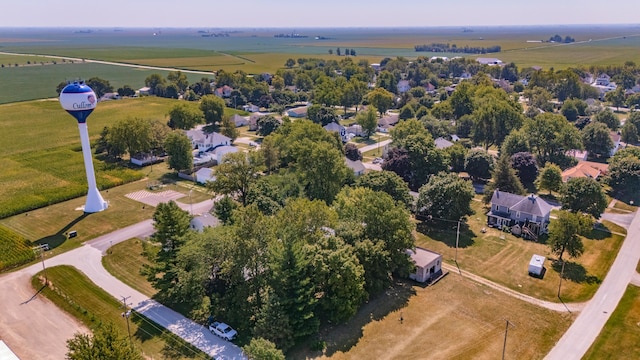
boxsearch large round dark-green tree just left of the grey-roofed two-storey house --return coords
[416,172,475,221]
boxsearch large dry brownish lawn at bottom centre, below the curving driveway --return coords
[289,273,572,359]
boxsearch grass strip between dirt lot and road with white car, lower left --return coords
[32,266,208,359]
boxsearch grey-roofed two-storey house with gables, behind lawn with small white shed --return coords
[487,189,551,240]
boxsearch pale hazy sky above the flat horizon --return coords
[0,0,640,28]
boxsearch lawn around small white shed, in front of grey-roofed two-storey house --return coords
[416,201,625,302]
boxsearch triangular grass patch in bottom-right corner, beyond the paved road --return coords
[583,285,640,359]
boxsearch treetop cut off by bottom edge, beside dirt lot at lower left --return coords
[66,323,143,360]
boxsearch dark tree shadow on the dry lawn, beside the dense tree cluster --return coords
[296,280,416,358]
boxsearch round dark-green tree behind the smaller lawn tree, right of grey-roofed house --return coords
[560,177,607,219]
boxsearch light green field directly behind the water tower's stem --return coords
[0,97,177,218]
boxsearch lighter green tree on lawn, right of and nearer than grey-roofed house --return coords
[547,210,593,261]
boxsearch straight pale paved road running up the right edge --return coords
[545,211,640,360]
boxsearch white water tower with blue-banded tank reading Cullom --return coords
[60,81,107,213]
